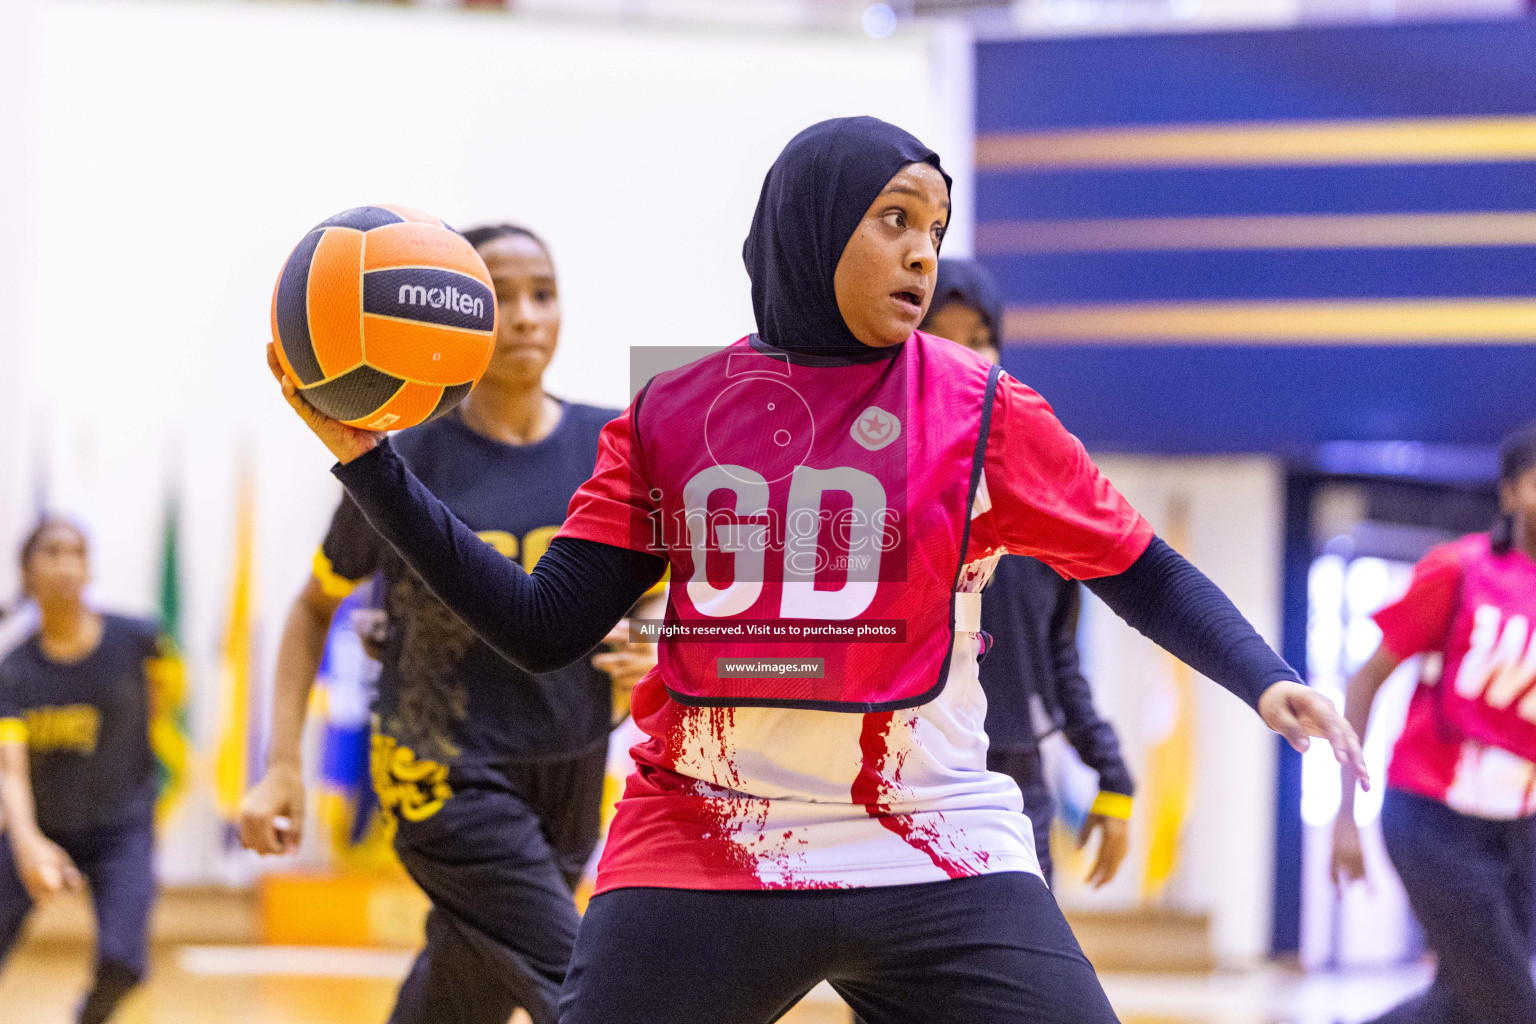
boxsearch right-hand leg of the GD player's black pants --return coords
[831,872,1117,1024]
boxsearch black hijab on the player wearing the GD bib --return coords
[742,117,951,350]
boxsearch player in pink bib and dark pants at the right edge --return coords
[1333,425,1536,1024]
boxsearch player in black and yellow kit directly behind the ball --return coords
[241,226,659,1024]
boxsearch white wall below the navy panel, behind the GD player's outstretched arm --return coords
[1057,457,1284,966]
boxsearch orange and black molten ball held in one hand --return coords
[272,206,496,430]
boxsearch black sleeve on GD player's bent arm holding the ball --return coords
[332,444,667,674]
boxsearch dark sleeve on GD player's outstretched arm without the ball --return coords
[1084,537,1301,711]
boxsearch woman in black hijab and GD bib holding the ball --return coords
[269,118,1362,1024]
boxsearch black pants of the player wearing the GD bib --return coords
[561,872,1115,1024]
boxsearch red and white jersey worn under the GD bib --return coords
[561,359,1152,892]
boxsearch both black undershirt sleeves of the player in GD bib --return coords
[332,442,1296,708]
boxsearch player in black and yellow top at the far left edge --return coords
[0,519,174,1024]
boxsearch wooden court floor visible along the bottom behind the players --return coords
[0,943,1425,1024]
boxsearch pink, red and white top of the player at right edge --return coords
[1375,534,1536,818]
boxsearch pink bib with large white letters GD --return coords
[636,333,998,712]
